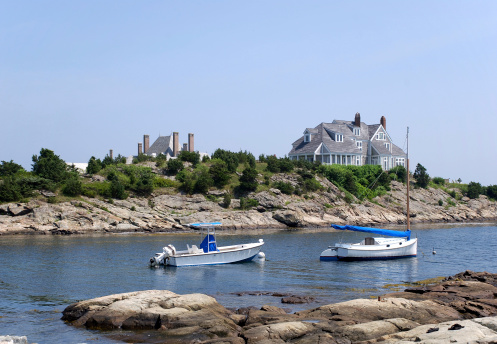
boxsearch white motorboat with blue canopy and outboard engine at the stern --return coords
[150,222,264,266]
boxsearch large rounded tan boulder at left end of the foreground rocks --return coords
[62,290,240,340]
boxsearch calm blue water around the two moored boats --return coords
[0,225,497,344]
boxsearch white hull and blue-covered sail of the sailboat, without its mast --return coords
[319,225,418,261]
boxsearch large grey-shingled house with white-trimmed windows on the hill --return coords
[288,113,407,170]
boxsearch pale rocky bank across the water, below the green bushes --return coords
[0,180,497,235]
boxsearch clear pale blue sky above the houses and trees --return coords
[0,0,497,185]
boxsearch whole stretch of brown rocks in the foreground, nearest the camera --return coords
[62,271,497,344]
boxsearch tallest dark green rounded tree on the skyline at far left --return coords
[32,148,70,183]
